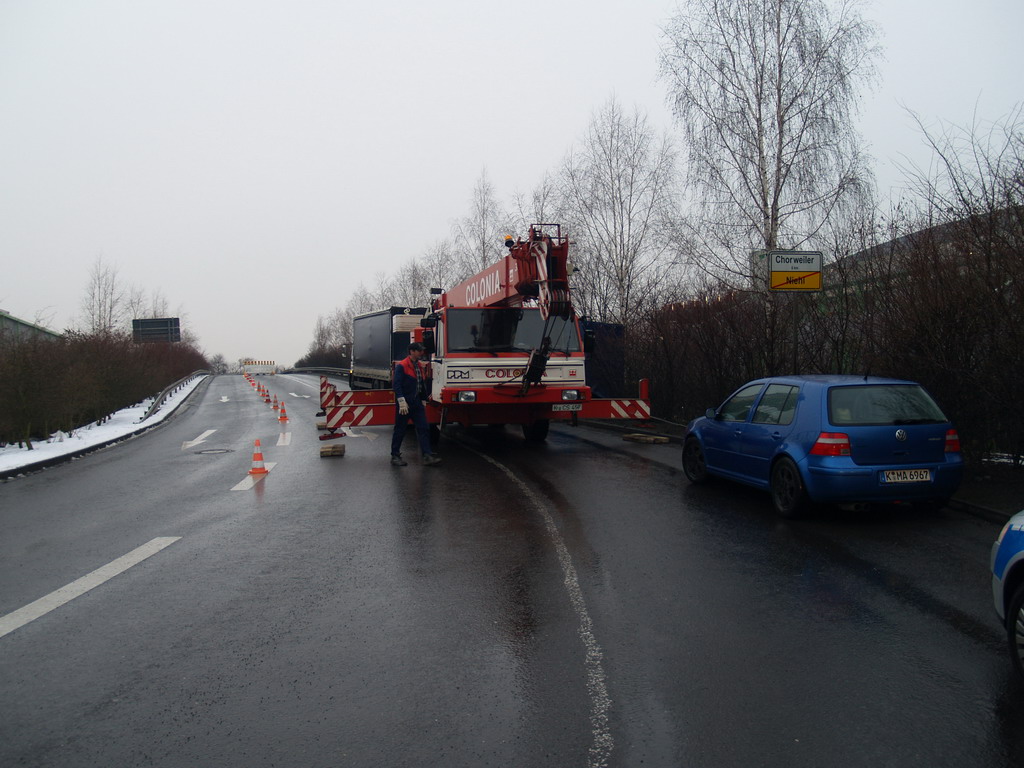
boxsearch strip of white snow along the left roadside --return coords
[0,375,206,472]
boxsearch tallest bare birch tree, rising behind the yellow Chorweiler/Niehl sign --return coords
[660,0,878,273]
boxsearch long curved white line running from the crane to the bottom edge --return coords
[463,444,613,768]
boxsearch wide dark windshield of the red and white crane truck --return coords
[445,307,580,352]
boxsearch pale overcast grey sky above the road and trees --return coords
[0,0,1024,365]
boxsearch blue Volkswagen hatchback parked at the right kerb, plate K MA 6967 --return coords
[682,376,964,517]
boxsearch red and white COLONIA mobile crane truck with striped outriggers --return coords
[321,224,650,441]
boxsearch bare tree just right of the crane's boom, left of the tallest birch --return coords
[560,98,678,323]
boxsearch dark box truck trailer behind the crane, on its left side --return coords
[348,306,427,389]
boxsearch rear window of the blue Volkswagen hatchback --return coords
[828,384,947,426]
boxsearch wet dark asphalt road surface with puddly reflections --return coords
[0,376,1024,767]
